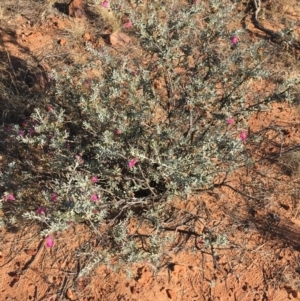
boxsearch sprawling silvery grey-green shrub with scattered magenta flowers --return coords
[2,1,293,273]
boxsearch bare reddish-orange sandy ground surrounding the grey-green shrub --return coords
[0,0,300,301]
